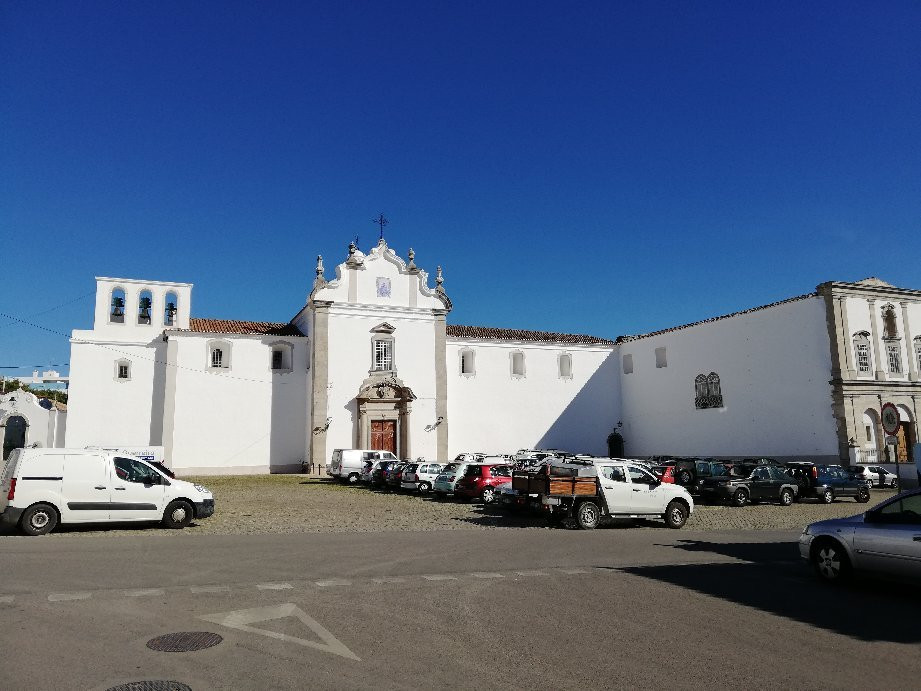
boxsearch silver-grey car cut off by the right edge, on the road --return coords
[799,489,921,582]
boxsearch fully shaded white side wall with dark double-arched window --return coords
[618,297,838,460]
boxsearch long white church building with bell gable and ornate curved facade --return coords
[66,240,921,475]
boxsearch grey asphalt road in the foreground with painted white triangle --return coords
[0,529,921,691]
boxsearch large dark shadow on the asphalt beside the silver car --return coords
[617,540,921,643]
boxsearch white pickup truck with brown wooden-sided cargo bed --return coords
[512,458,694,530]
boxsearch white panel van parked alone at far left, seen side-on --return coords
[0,449,214,535]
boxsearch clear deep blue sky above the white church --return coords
[0,0,921,374]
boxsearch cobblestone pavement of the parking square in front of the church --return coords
[0,475,893,539]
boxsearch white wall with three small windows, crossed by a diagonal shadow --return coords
[447,338,620,457]
